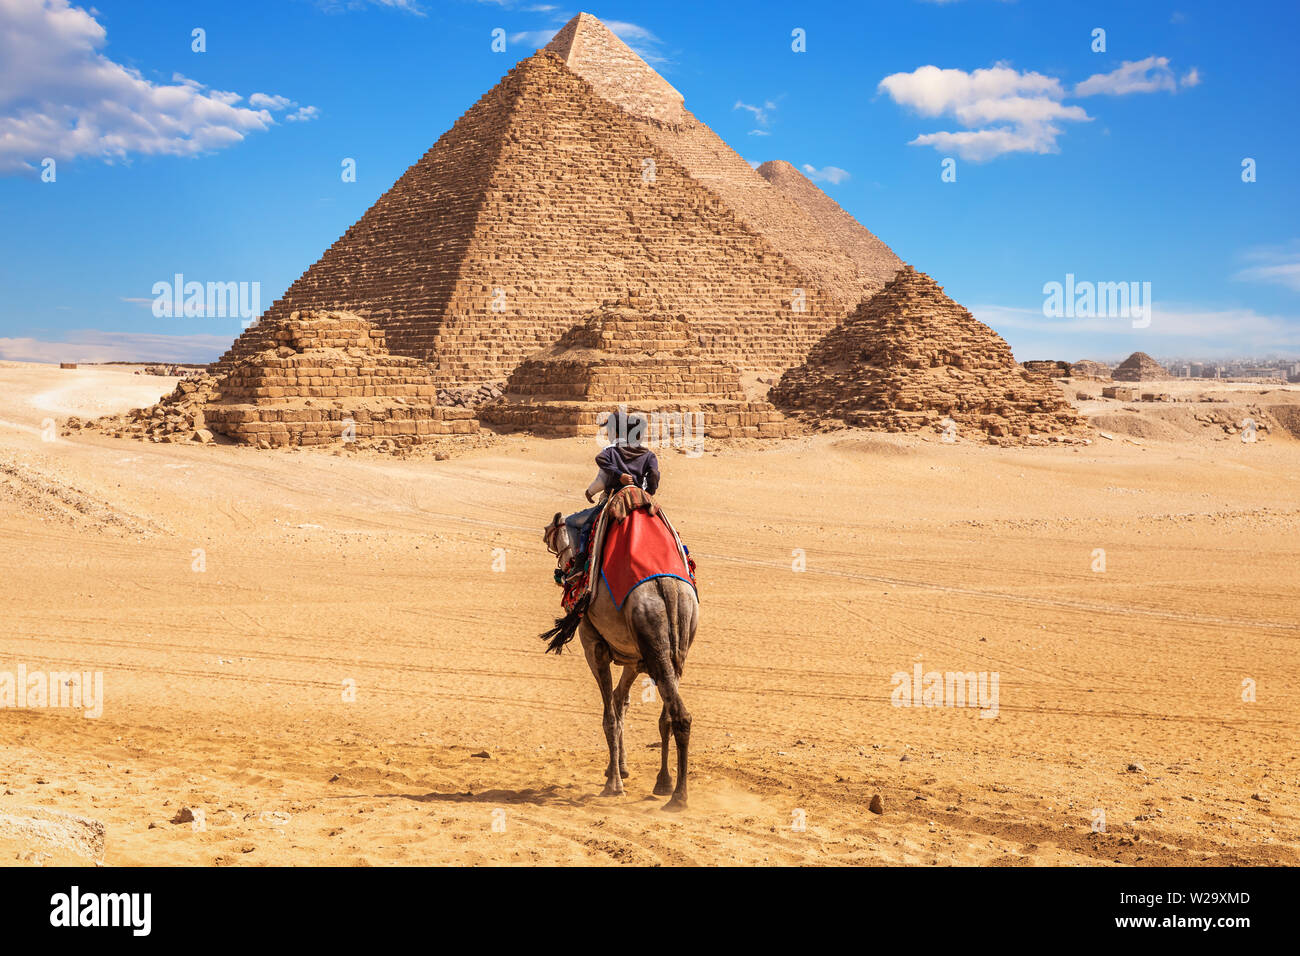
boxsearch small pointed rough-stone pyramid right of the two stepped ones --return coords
[768,265,1079,444]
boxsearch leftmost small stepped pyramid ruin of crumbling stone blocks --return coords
[203,311,478,447]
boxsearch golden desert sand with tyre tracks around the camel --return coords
[0,365,1300,865]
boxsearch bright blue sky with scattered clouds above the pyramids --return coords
[0,0,1300,362]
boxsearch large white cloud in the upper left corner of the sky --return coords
[0,0,314,174]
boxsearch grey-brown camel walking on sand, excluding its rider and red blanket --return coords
[542,514,699,810]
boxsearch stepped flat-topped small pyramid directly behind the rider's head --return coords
[478,290,793,444]
